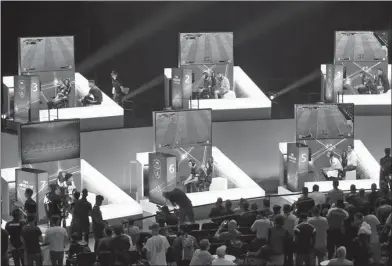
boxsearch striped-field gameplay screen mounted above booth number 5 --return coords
[295,104,354,140]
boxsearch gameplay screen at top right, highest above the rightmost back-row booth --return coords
[335,31,388,63]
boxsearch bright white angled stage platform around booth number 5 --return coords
[278,140,380,202]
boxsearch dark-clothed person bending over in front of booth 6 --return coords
[162,188,195,224]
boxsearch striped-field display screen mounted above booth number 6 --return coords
[155,109,212,149]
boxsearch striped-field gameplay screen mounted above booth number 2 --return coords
[179,32,234,65]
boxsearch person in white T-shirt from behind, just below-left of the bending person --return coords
[144,223,170,266]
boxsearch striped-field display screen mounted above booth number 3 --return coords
[19,36,75,74]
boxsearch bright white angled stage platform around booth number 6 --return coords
[132,147,265,213]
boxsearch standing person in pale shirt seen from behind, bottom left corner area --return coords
[44,215,68,266]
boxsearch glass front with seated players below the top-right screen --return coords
[340,61,391,97]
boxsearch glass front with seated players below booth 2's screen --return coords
[183,64,237,100]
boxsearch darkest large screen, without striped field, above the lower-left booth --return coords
[19,119,80,164]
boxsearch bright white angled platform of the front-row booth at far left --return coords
[1,159,143,226]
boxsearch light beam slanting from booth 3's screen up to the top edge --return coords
[78,2,213,73]
